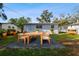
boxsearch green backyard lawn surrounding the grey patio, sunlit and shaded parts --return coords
[0,34,79,56]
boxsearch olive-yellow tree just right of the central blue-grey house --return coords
[53,14,73,30]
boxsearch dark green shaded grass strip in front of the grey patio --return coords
[0,48,71,56]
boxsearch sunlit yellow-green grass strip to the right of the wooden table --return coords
[51,33,79,41]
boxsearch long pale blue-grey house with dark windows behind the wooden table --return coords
[24,23,58,34]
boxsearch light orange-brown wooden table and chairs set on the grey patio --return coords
[18,31,52,47]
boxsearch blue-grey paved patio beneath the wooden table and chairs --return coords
[6,38,65,48]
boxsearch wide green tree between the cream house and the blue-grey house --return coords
[9,17,31,32]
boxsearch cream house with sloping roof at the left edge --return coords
[0,23,21,31]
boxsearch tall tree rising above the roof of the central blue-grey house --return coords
[37,10,53,23]
